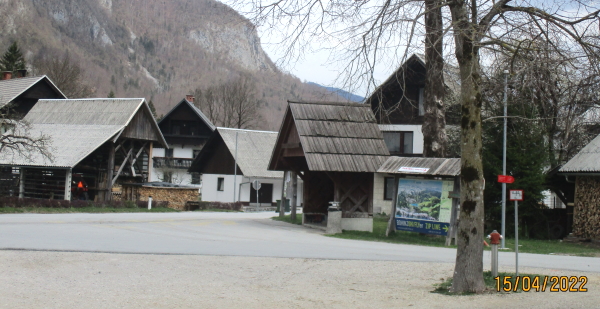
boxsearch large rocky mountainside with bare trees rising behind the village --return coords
[0,0,338,130]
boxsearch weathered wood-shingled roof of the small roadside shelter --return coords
[269,101,390,172]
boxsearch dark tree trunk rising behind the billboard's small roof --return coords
[422,0,448,158]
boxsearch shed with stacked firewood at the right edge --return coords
[559,135,600,242]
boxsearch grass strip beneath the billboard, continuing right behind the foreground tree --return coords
[327,215,600,257]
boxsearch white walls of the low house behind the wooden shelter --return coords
[201,174,303,206]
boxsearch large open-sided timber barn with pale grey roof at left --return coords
[0,98,167,201]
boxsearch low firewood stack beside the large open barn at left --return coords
[136,187,199,210]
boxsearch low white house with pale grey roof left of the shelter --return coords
[190,128,302,207]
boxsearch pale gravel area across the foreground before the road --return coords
[0,250,600,308]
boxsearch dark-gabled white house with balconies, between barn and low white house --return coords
[150,95,215,187]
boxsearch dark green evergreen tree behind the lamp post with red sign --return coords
[483,74,548,238]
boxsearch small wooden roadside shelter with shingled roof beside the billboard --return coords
[269,101,389,231]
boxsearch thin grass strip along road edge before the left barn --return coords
[0,207,179,214]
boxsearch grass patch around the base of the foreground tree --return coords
[431,271,552,295]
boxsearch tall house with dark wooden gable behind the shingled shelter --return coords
[365,54,460,213]
